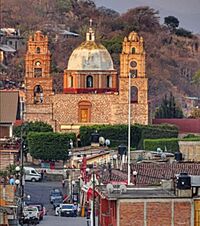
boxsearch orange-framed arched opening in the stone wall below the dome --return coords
[78,101,92,123]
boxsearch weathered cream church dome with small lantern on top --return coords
[67,23,114,71]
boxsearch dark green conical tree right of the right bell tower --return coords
[155,93,183,118]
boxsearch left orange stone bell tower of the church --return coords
[25,31,53,121]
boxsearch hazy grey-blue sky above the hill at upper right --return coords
[93,0,200,33]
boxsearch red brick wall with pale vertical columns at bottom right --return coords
[118,199,194,226]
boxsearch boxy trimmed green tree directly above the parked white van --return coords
[28,132,76,161]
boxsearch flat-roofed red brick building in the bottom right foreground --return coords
[98,187,200,226]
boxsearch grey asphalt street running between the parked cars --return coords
[25,182,87,226]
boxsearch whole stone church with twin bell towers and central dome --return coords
[24,24,148,132]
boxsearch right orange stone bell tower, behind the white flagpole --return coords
[119,32,148,124]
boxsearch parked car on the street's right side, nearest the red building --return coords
[55,204,77,217]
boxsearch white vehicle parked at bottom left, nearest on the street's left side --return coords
[23,206,40,224]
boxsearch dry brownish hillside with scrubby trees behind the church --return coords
[1,0,200,111]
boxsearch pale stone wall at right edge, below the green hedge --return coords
[179,141,200,162]
